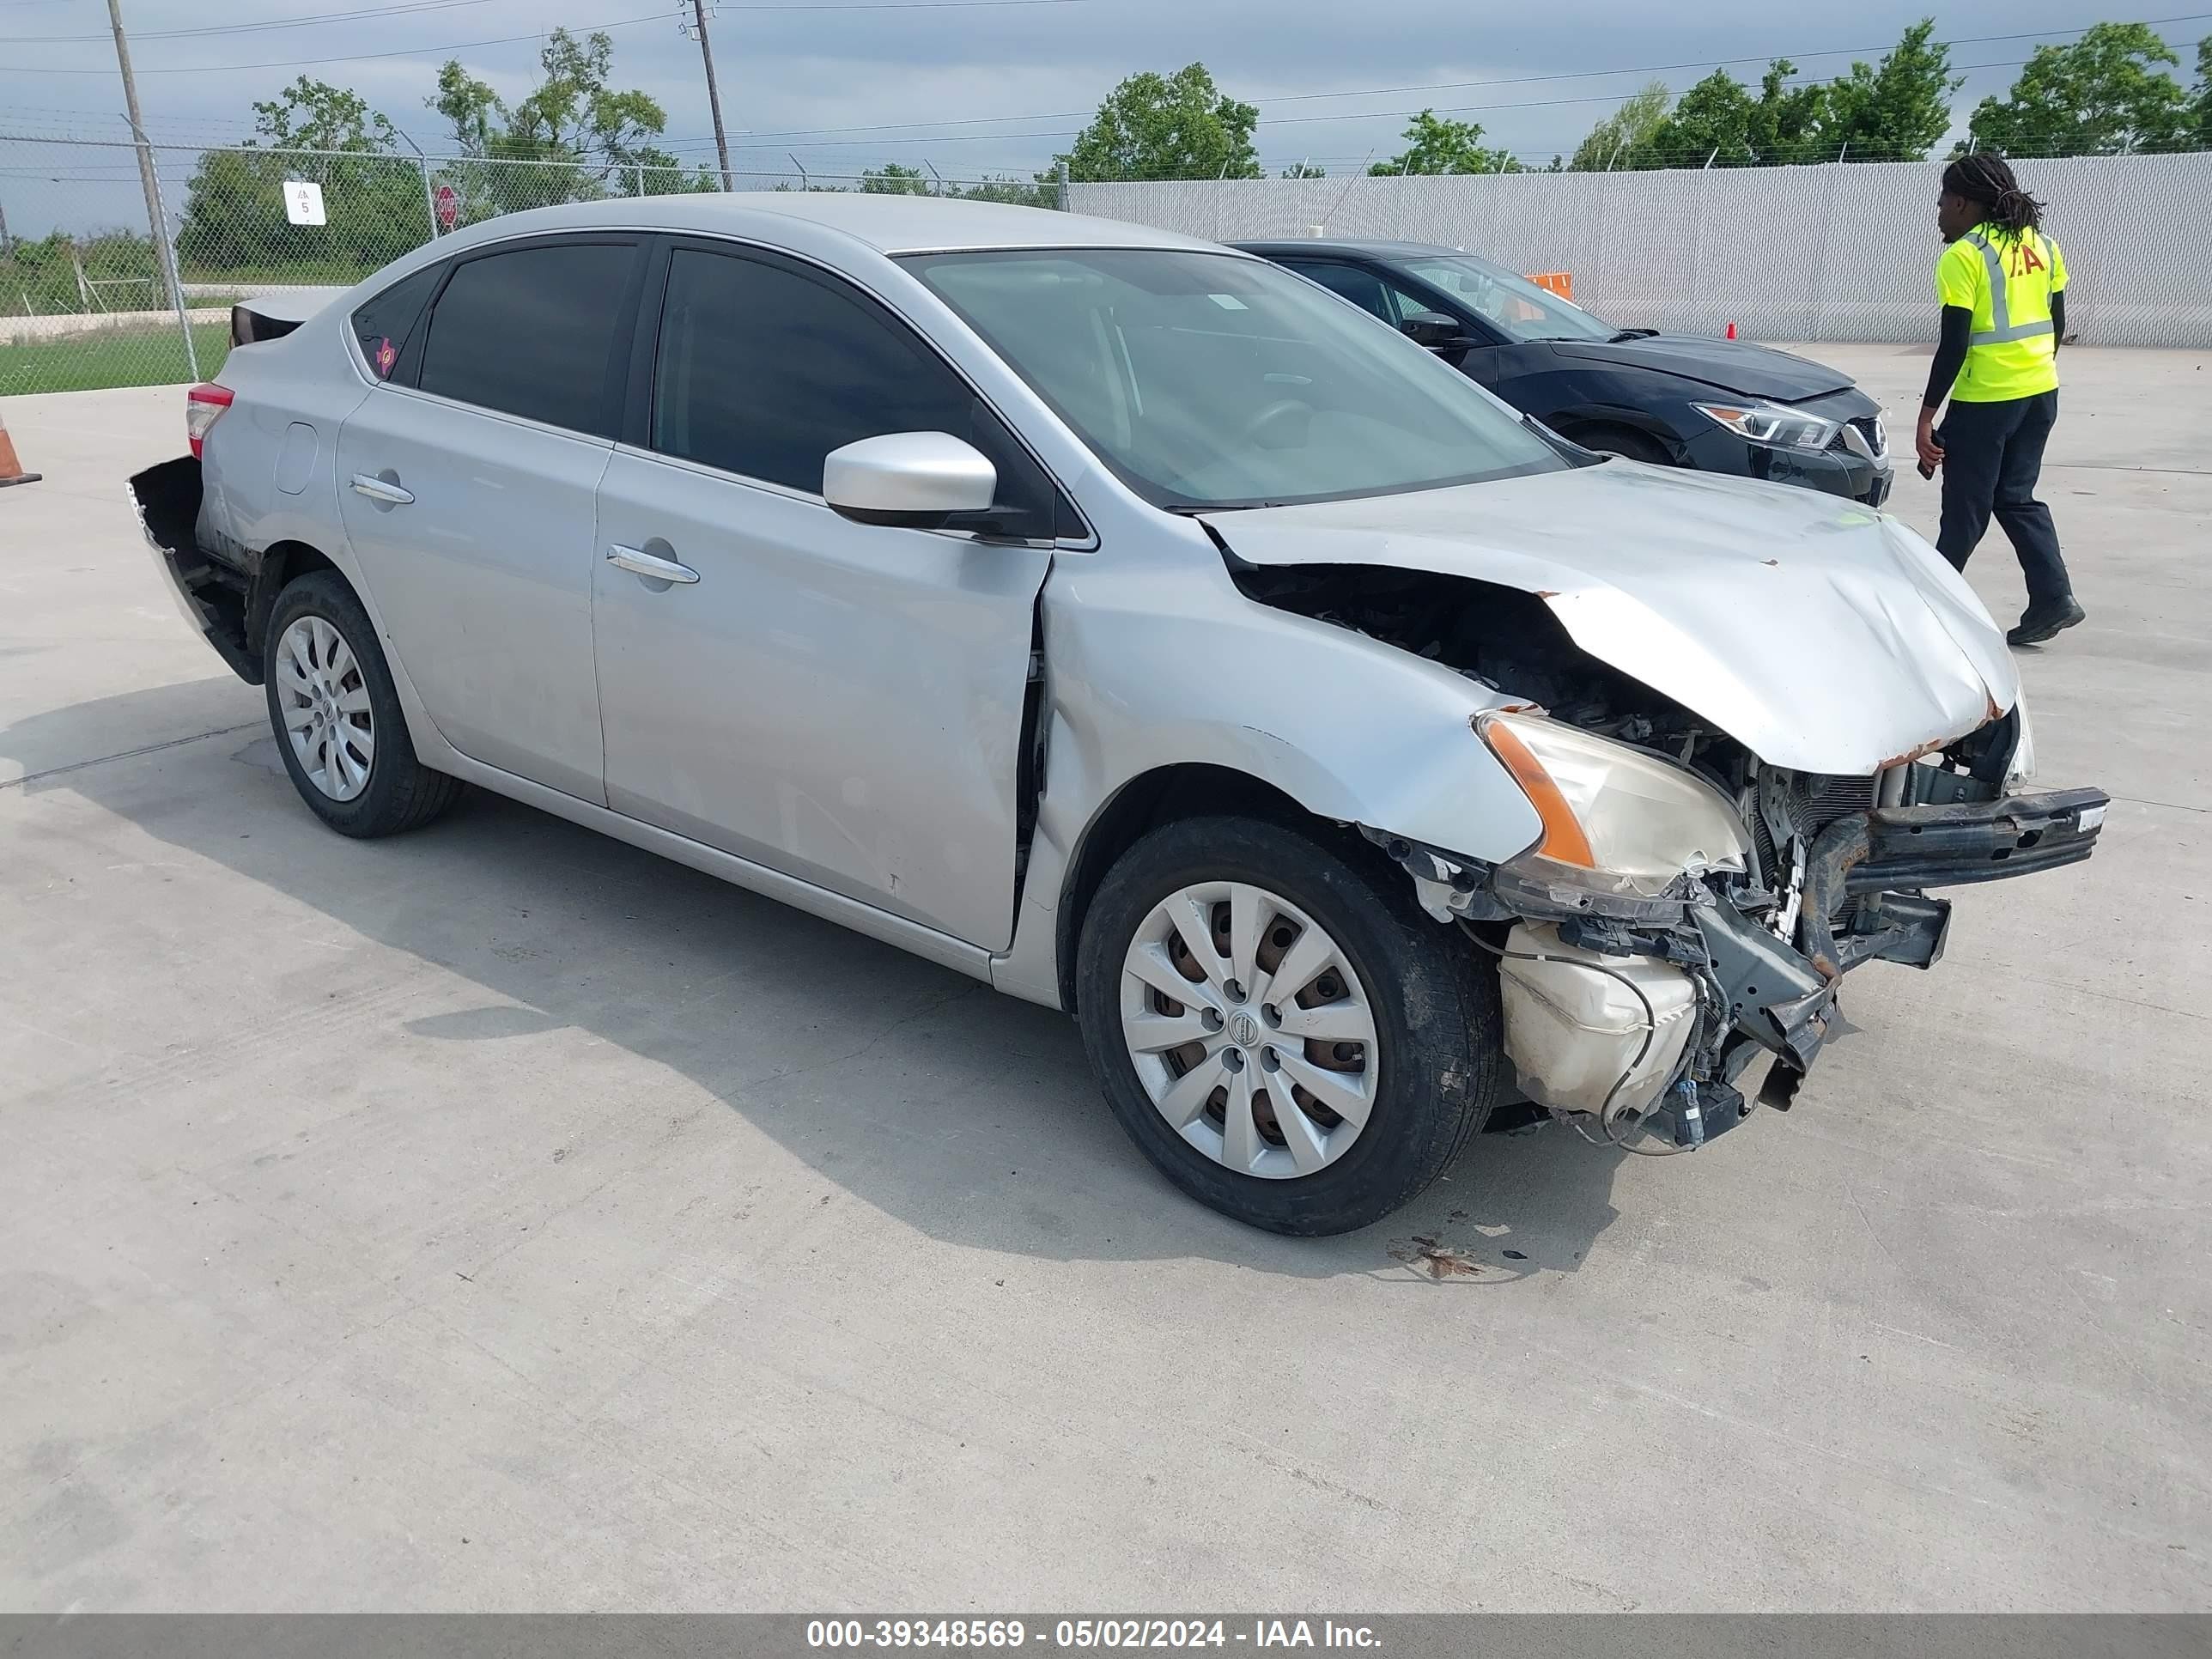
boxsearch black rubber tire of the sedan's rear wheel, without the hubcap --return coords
[261,571,462,838]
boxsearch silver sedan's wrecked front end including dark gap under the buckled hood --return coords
[1237,546,2106,1148]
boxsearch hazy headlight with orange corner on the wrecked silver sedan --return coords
[1475,714,1750,898]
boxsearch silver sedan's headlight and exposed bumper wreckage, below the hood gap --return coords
[1367,710,2108,1148]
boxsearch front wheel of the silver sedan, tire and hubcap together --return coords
[1078,818,1500,1234]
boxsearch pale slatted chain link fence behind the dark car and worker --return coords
[1068,153,2212,347]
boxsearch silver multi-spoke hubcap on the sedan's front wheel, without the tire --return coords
[1121,880,1380,1179]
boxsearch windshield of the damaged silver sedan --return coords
[902,248,1566,511]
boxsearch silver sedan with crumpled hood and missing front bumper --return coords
[133,195,2104,1232]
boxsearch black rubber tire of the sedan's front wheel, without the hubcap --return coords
[1075,817,1504,1234]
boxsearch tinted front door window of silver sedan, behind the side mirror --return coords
[653,248,1053,535]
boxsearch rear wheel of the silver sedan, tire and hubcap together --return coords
[261,571,460,836]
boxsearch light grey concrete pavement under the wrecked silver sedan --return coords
[0,347,2212,1610]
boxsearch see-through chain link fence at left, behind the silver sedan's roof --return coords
[0,135,1051,396]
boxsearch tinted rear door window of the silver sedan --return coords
[420,243,637,431]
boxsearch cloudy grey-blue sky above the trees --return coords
[0,0,2212,184]
